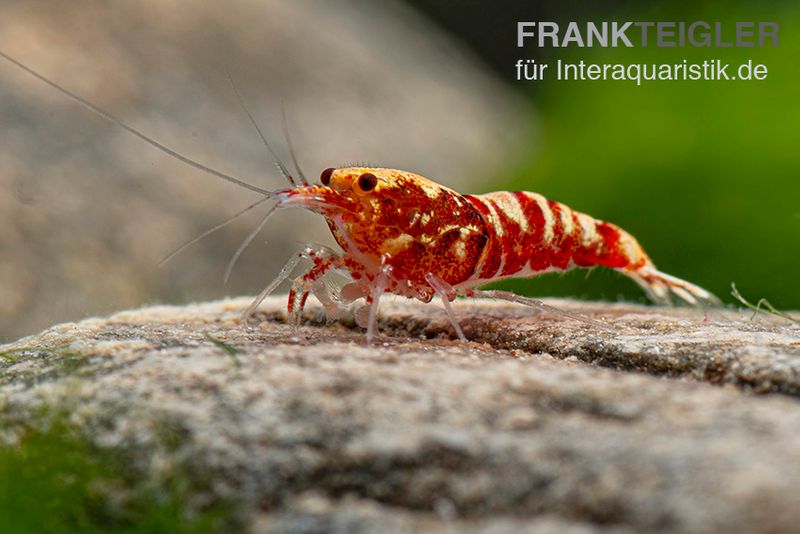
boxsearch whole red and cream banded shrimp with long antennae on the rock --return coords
[0,52,718,343]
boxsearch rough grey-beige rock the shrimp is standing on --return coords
[0,298,800,532]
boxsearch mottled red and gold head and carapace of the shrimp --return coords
[286,167,481,288]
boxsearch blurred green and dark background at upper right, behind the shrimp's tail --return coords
[414,0,800,309]
